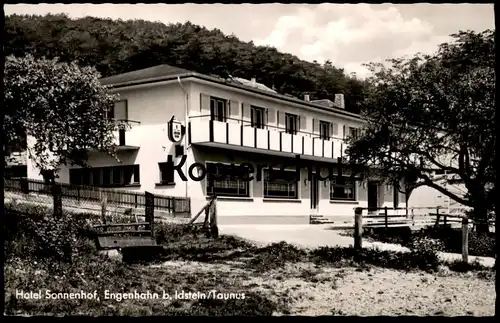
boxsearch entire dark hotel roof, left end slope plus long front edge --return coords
[100,64,360,119]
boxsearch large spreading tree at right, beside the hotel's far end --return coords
[348,30,496,232]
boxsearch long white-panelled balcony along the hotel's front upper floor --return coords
[190,116,346,161]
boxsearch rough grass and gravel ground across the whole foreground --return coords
[4,205,495,316]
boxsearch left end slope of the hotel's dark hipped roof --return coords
[100,64,193,85]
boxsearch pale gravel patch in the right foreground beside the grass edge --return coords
[154,261,496,316]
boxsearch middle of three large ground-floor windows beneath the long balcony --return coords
[264,169,300,199]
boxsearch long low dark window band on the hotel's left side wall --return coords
[69,165,140,186]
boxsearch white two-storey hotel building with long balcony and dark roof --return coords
[27,65,406,224]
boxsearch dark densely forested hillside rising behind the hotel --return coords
[4,15,366,112]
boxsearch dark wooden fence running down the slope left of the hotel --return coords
[4,178,191,213]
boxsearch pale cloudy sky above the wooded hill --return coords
[4,3,495,77]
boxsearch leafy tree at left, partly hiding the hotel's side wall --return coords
[4,55,116,182]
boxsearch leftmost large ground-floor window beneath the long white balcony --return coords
[206,163,250,197]
